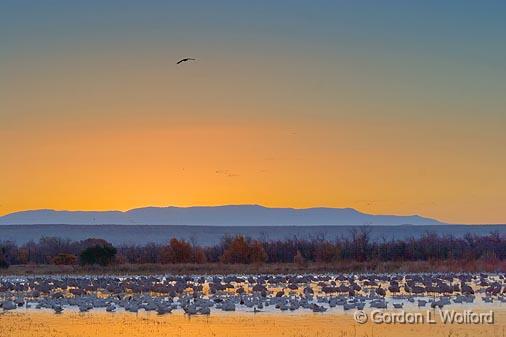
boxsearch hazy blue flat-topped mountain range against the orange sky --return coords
[0,205,444,226]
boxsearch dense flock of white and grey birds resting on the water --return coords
[0,273,506,315]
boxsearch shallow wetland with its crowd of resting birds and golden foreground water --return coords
[0,273,506,337]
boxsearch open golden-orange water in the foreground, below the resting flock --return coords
[0,310,506,337]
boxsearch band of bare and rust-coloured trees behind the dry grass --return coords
[0,227,506,268]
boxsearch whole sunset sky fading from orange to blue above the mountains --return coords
[0,0,506,223]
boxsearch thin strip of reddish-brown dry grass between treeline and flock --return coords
[0,260,506,275]
